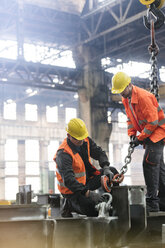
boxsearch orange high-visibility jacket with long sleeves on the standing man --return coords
[122,86,165,143]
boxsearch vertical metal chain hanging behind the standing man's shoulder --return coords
[148,21,159,101]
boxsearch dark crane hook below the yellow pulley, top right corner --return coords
[143,3,165,30]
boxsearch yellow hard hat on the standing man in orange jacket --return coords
[111,71,131,94]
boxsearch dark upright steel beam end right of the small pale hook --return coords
[112,186,147,230]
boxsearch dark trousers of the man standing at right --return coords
[143,139,165,211]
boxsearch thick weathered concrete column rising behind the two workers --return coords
[73,46,112,153]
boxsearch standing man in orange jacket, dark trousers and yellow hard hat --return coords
[111,72,165,212]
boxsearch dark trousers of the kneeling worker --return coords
[63,167,118,217]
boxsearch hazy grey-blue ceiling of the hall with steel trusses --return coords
[0,0,165,99]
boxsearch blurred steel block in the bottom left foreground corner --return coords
[0,220,55,248]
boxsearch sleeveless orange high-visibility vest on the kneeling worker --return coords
[53,138,100,194]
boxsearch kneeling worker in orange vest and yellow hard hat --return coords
[53,118,118,217]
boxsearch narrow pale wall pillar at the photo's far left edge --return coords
[0,139,6,200]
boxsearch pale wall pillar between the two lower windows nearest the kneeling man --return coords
[40,140,49,193]
